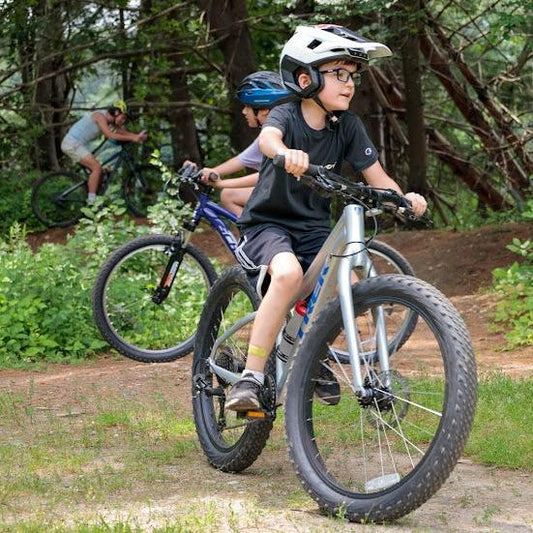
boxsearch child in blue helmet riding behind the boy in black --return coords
[197,70,294,216]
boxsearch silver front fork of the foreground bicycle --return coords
[337,205,390,398]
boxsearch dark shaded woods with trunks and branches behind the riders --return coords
[0,0,533,224]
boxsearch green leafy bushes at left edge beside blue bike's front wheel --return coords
[0,205,146,367]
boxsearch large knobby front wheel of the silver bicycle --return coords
[285,275,477,522]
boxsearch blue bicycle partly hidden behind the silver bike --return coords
[92,165,416,363]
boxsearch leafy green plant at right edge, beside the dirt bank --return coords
[492,230,533,348]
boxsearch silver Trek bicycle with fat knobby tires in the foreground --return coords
[192,161,477,522]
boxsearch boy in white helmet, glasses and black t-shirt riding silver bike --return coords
[225,25,426,411]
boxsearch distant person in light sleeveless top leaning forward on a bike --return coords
[61,100,147,203]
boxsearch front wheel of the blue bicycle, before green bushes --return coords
[92,235,217,363]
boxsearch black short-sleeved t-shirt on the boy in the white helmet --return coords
[239,102,378,231]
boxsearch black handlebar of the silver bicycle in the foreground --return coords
[273,155,426,220]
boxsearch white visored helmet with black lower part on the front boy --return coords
[280,24,392,98]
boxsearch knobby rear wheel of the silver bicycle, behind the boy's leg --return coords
[192,267,275,472]
